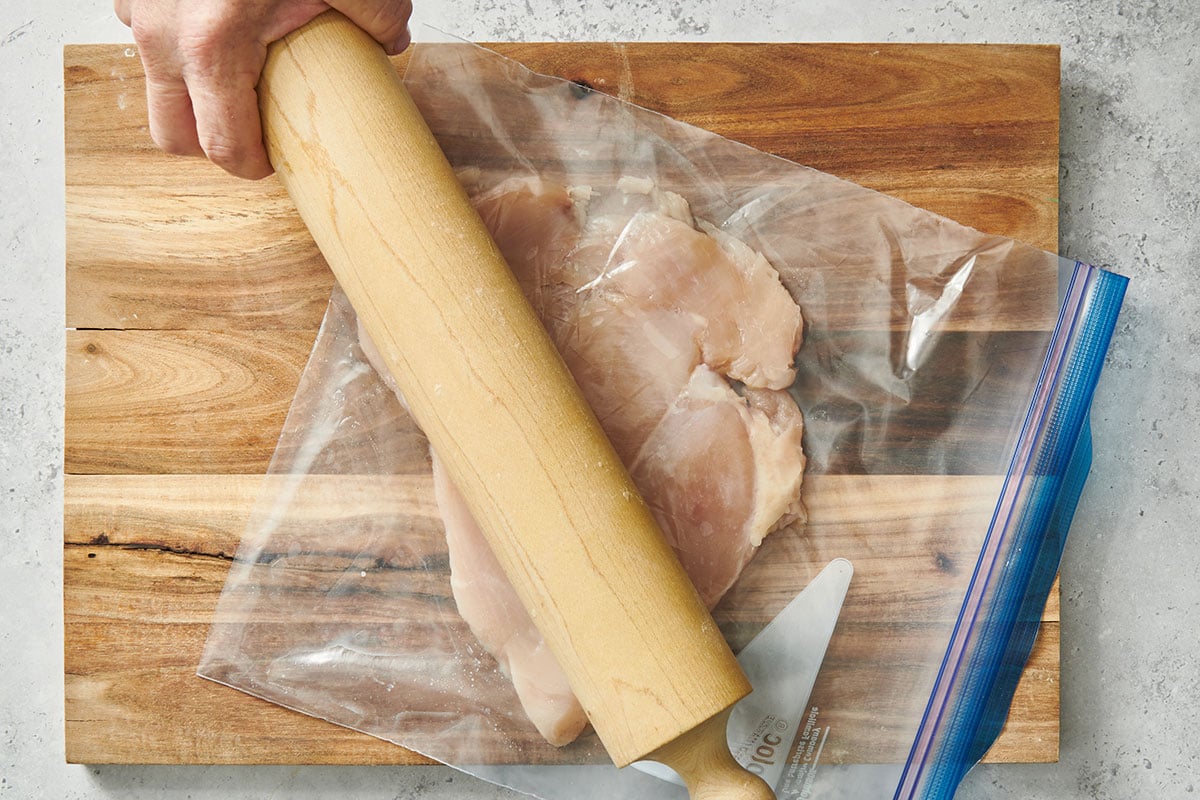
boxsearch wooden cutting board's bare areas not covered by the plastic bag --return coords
[64,43,1058,764]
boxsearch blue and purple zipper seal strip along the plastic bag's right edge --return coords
[894,261,1129,800]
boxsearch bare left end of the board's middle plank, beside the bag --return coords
[65,330,314,473]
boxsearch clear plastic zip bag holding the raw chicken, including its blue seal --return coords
[199,44,1126,798]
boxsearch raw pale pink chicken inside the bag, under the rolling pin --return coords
[364,174,805,745]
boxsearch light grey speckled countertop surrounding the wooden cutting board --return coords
[0,0,1200,800]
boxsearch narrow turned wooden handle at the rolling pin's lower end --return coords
[647,709,775,800]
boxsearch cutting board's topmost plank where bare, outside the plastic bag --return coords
[64,43,1058,330]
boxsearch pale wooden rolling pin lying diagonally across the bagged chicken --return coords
[259,12,774,800]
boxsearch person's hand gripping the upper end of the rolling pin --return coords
[114,0,413,179]
